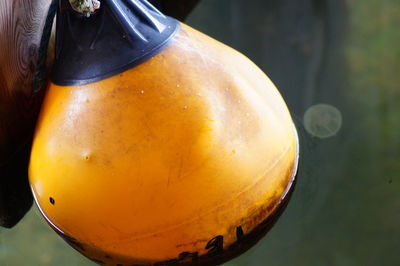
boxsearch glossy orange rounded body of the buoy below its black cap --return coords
[29,21,298,265]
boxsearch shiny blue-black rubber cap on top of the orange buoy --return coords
[52,0,179,86]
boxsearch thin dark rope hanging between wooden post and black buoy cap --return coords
[32,0,60,93]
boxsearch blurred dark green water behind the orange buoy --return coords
[0,0,400,266]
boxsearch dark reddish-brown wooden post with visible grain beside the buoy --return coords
[0,0,51,227]
